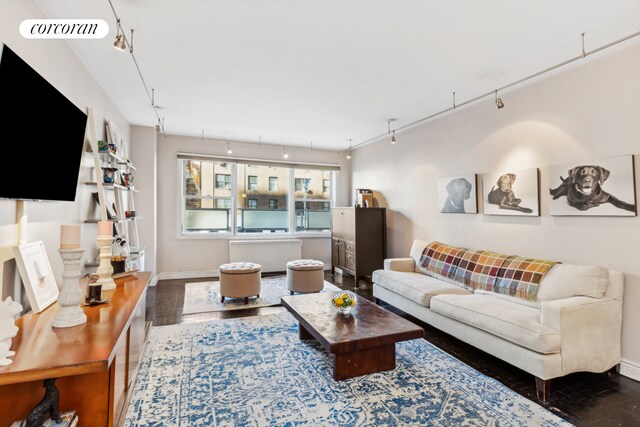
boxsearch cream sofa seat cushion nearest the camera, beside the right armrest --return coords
[431,294,561,354]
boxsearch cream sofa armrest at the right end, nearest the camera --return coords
[540,297,622,372]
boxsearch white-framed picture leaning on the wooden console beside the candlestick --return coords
[13,241,59,313]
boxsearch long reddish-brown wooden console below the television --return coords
[0,272,151,427]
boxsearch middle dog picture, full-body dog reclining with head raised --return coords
[482,168,540,216]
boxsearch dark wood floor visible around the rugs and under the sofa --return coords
[147,272,640,427]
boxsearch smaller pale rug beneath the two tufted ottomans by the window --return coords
[182,276,340,314]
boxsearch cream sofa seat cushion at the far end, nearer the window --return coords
[372,270,471,307]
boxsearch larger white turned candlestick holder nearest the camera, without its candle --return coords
[53,248,87,328]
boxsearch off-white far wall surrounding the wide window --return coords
[152,135,350,279]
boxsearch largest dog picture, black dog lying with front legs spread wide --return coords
[549,155,637,216]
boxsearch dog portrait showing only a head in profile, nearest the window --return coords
[438,174,478,213]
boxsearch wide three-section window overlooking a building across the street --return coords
[178,153,337,236]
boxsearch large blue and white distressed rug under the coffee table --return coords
[124,312,570,427]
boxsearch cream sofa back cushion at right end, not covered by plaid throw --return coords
[537,264,609,301]
